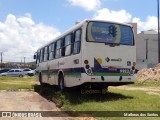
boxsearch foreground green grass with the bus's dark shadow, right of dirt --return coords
[35,83,160,120]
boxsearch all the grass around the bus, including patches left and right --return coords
[0,77,160,120]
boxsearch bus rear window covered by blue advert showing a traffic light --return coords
[87,22,134,46]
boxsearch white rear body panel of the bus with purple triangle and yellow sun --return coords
[82,43,136,83]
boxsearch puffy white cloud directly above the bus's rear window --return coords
[93,8,132,22]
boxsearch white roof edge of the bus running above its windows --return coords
[38,19,132,50]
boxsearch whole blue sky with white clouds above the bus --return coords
[0,0,157,62]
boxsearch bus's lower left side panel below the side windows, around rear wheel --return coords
[37,54,81,87]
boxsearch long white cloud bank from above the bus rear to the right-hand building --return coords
[93,8,158,32]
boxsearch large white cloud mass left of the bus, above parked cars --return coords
[0,14,60,61]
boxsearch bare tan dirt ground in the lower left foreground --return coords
[0,91,93,120]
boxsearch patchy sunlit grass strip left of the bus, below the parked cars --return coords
[0,76,37,90]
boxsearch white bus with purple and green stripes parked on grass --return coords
[34,20,136,90]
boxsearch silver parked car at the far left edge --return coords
[0,69,24,77]
